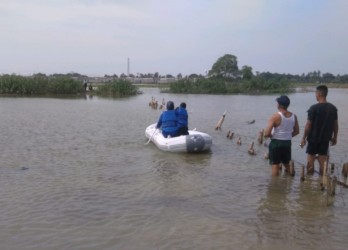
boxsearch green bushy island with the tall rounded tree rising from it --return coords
[169,54,292,94]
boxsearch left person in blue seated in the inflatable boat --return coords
[156,101,178,137]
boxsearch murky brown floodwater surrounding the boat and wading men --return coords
[0,88,348,250]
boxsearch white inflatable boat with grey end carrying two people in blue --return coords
[145,123,213,153]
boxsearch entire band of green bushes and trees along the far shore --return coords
[0,54,348,96]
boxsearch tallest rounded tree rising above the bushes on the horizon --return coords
[208,54,239,78]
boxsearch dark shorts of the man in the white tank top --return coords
[268,139,291,165]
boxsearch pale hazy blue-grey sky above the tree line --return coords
[0,0,348,76]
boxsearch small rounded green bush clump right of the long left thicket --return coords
[97,79,138,97]
